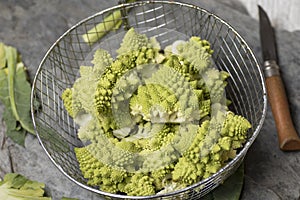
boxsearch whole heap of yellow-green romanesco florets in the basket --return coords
[62,28,251,197]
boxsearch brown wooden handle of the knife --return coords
[266,75,300,151]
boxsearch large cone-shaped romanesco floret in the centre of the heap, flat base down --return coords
[130,66,201,123]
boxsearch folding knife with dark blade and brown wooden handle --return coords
[258,6,300,151]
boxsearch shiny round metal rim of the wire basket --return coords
[30,0,267,199]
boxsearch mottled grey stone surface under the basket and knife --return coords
[0,0,300,200]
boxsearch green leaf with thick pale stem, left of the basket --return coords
[0,43,34,145]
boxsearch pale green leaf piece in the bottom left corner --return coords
[0,173,51,200]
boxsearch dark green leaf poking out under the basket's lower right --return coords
[201,163,244,200]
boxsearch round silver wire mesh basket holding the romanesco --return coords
[31,1,266,199]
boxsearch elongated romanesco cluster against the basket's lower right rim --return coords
[172,111,251,185]
